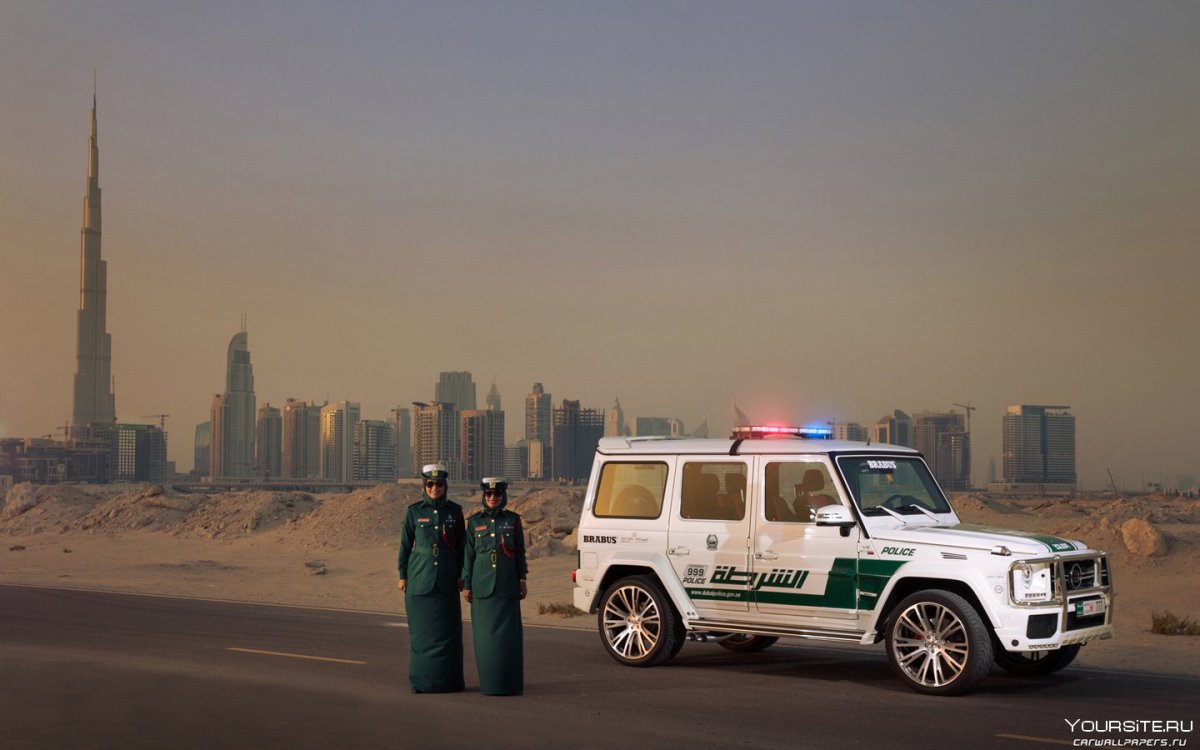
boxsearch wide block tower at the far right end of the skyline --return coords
[1001,404,1078,492]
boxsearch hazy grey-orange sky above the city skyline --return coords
[0,0,1200,487]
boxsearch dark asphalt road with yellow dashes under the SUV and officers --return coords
[0,586,1200,750]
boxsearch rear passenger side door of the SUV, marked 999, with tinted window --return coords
[667,457,750,617]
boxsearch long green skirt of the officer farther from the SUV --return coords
[404,590,466,692]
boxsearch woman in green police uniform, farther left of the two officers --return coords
[396,463,463,692]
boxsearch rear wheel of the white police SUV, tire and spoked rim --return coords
[596,576,685,667]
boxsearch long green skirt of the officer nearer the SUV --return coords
[470,596,524,695]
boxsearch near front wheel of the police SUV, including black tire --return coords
[887,589,992,695]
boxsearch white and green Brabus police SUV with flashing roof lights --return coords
[575,428,1114,695]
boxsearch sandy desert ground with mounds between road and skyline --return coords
[0,484,1200,676]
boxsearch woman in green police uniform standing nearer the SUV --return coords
[462,476,529,695]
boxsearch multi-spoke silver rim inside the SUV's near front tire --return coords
[892,601,971,688]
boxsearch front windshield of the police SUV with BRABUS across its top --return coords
[838,456,950,516]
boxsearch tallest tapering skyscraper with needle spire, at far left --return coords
[71,89,116,434]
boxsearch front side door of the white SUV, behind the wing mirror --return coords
[750,456,858,620]
